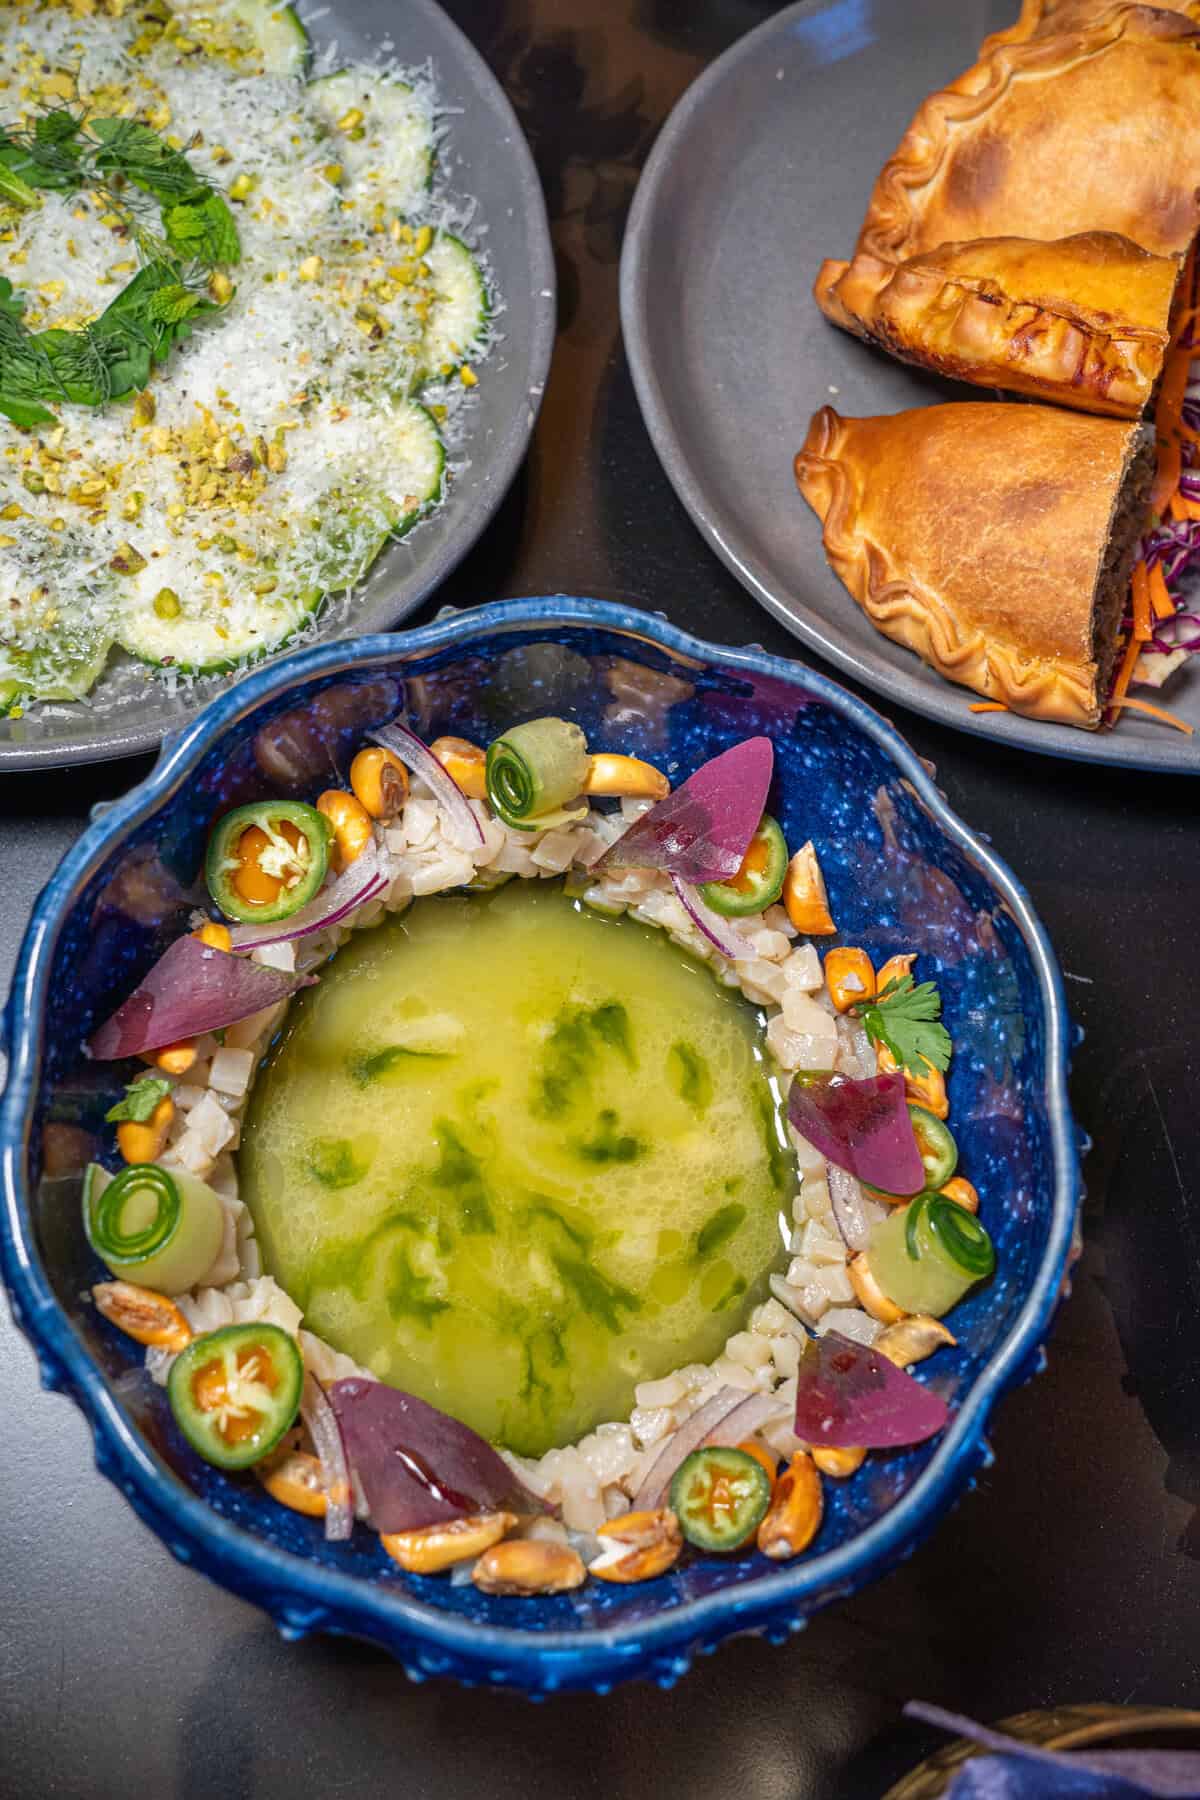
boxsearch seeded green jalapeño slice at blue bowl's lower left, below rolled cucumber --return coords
[167,1323,304,1469]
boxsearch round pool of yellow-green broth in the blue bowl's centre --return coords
[241,882,793,1454]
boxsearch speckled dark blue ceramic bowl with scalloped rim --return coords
[0,598,1079,1694]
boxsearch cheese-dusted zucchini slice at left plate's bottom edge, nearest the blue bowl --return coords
[117,583,322,675]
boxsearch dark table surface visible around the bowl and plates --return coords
[0,0,1200,1800]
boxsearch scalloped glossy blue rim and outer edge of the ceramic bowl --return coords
[0,596,1079,1694]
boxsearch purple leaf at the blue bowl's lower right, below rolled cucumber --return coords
[795,1332,950,1451]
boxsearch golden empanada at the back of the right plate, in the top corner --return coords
[858,5,1200,263]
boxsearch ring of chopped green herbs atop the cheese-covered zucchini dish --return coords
[0,106,241,427]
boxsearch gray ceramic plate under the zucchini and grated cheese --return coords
[0,0,554,769]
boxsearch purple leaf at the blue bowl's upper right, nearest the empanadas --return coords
[596,738,775,884]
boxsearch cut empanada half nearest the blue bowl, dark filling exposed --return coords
[795,401,1153,729]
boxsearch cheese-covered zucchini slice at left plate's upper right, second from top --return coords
[308,65,434,212]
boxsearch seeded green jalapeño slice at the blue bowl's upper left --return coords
[205,799,331,925]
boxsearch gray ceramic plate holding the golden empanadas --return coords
[621,0,1200,774]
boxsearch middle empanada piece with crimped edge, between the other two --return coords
[813,232,1182,419]
